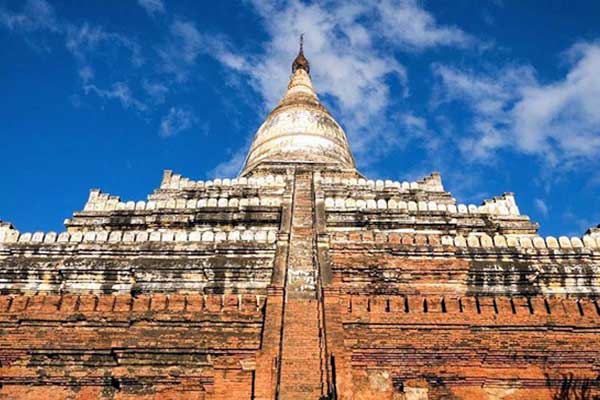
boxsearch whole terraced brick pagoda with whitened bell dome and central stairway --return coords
[0,43,600,400]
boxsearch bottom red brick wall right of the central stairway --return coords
[326,294,600,399]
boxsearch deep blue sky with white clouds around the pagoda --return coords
[0,0,600,235]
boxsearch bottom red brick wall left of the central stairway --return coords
[0,294,265,399]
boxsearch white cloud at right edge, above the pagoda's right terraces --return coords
[435,43,600,165]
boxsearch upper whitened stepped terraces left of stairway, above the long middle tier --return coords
[65,171,287,232]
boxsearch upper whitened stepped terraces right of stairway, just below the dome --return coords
[315,173,538,236]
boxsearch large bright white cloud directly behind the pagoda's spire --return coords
[196,0,475,166]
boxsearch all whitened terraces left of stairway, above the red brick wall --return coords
[0,171,289,293]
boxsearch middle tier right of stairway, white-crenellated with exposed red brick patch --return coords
[328,230,600,298]
